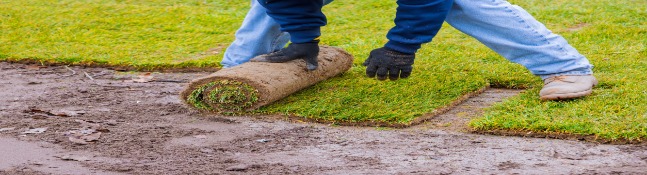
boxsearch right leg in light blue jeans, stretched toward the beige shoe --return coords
[446,0,593,79]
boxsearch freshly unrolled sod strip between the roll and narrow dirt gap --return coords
[260,67,494,127]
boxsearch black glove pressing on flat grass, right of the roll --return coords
[364,47,416,80]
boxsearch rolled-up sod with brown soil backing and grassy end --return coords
[180,46,353,113]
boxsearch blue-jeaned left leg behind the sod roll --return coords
[220,0,332,68]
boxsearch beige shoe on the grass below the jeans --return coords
[539,75,598,100]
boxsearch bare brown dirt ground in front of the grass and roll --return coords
[0,63,647,174]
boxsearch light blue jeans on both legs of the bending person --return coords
[221,0,593,79]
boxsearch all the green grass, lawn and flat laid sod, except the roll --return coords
[0,0,647,140]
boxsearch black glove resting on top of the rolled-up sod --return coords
[250,42,319,71]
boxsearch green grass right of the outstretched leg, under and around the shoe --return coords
[470,0,647,143]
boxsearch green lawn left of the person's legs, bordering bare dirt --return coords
[0,0,246,69]
